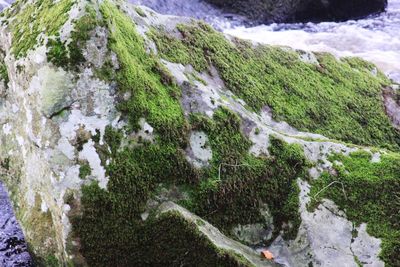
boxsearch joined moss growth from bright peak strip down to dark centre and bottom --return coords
[71,1,306,266]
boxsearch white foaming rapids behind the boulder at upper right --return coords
[224,0,400,82]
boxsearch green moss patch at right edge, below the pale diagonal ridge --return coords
[311,151,400,267]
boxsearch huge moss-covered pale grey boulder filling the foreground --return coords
[0,0,400,266]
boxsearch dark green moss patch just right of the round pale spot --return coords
[183,109,308,241]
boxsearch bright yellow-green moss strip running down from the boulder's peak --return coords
[101,2,186,146]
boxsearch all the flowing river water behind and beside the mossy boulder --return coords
[0,0,400,267]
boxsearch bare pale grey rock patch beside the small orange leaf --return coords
[269,180,384,267]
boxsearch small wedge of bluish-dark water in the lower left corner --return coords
[0,182,32,267]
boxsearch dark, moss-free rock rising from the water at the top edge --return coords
[206,0,387,23]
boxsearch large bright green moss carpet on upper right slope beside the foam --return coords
[149,22,400,149]
